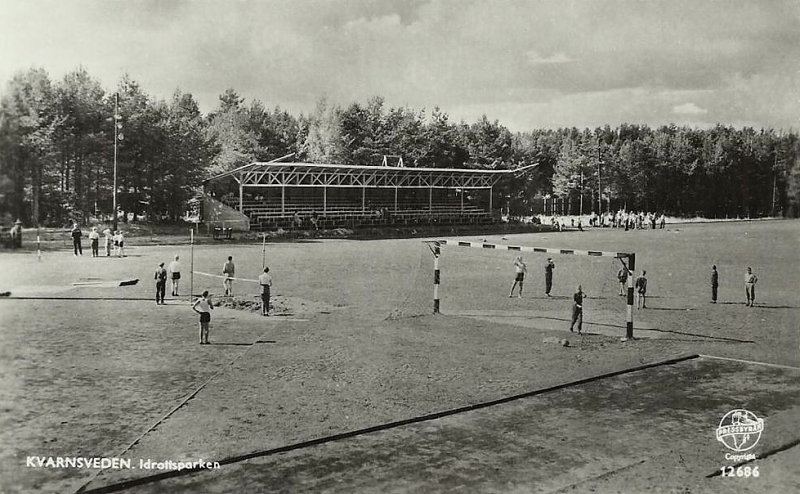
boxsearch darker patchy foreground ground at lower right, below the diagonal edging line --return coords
[76,355,800,493]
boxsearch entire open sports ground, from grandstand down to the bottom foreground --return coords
[0,221,800,493]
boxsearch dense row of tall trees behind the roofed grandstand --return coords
[0,68,800,225]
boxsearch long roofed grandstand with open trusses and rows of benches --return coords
[203,161,536,231]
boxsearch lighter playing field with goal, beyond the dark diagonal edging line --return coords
[0,221,800,492]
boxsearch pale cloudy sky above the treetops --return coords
[0,0,800,131]
